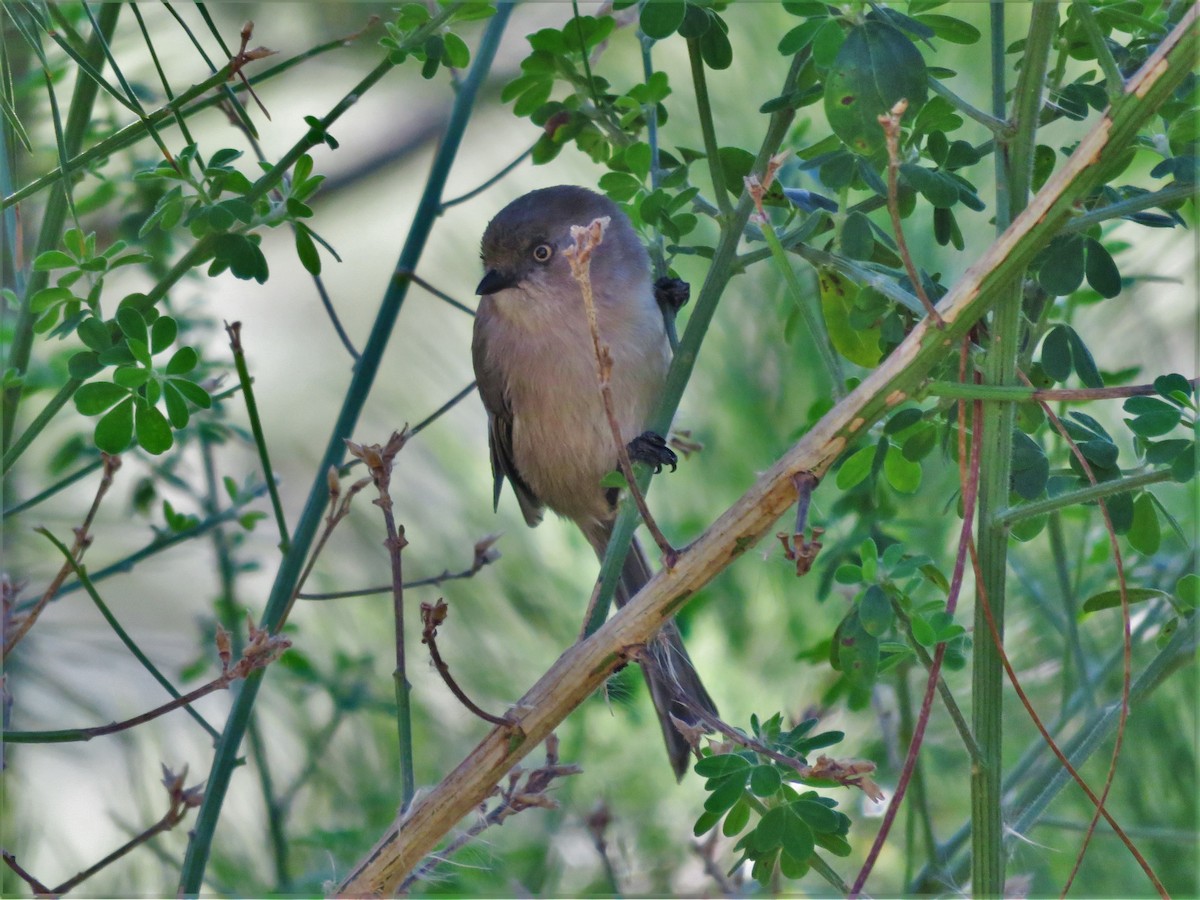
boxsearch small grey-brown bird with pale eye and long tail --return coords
[472,185,716,778]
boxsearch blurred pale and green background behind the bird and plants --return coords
[0,2,1200,896]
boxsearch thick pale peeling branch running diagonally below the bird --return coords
[337,8,1196,896]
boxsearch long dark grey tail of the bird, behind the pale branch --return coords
[588,529,718,779]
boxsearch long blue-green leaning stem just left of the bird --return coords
[179,4,514,895]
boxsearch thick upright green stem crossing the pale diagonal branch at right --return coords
[971,2,1058,896]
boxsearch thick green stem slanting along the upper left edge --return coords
[0,4,121,450]
